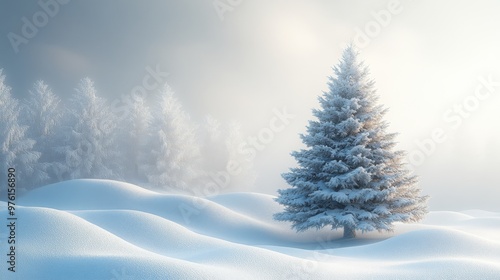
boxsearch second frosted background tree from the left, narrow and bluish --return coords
[24,80,62,185]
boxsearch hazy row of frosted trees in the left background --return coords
[0,69,253,190]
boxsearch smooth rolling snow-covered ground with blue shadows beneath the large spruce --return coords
[0,180,500,280]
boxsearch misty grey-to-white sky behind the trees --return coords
[0,0,500,211]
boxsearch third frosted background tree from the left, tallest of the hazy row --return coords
[58,78,121,179]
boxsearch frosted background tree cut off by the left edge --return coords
[0,69,41,189]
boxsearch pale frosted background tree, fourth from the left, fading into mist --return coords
[142,84,200,189]
